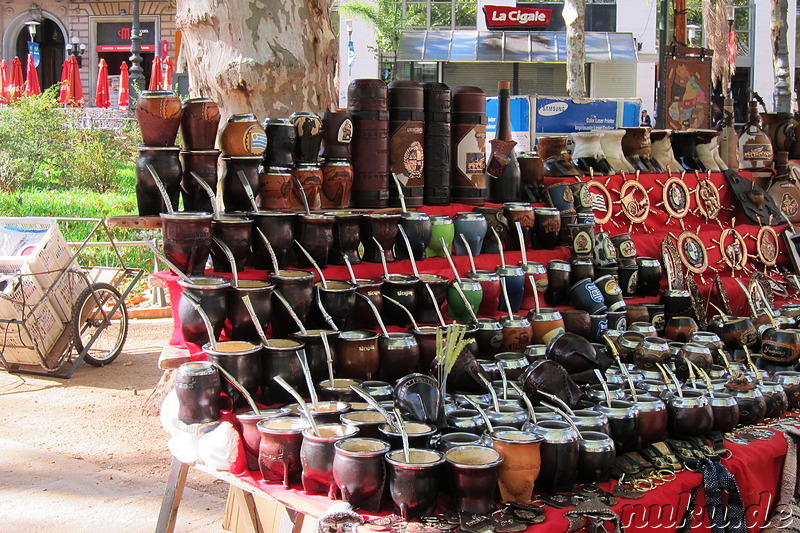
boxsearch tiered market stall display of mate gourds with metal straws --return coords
[134,80,800,531]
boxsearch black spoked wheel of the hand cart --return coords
[71,283,128,366]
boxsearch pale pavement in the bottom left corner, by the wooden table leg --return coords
[0,435,225,533]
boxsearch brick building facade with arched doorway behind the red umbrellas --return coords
[0,0,179,105]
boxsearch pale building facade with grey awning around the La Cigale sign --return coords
[340,0,800,120]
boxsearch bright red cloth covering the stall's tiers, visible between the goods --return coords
[157,173,788,533]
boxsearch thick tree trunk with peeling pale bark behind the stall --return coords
[176,0,339,119]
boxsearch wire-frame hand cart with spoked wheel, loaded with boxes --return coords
[0,217,144,378]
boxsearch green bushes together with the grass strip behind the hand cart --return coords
[0,86,155,270]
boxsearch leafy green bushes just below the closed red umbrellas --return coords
[0,86,137,192]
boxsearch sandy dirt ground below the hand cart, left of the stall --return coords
[0,319,228,500]
